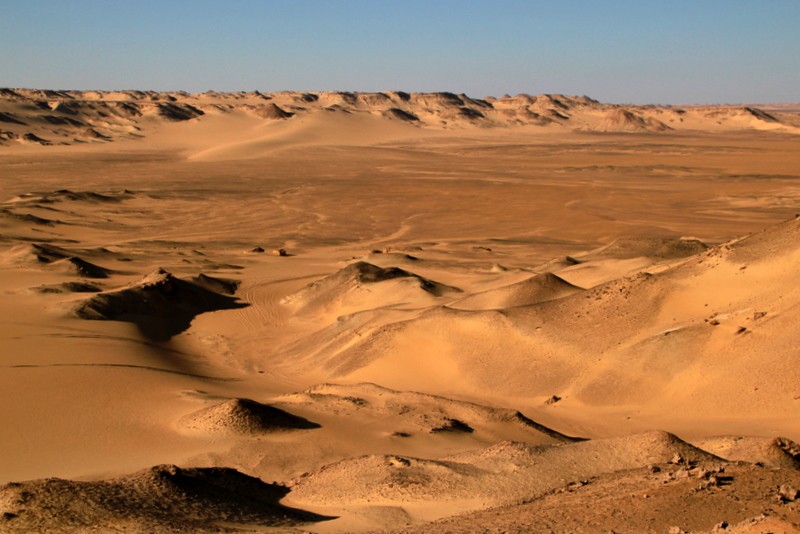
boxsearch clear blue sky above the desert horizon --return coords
[0,0,800,104]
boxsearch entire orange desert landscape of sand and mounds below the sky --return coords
[0,89,800,532]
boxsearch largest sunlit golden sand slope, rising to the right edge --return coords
[258,216,800,438]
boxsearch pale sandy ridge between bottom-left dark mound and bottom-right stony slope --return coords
[290,432,721,519]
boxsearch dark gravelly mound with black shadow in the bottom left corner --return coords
[0,465,332,532]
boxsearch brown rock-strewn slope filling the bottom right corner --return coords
[393,464,798,534]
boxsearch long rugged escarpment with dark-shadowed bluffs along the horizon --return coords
[0,89,800,146]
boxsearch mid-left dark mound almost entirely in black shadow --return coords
[75,269,247,341]
